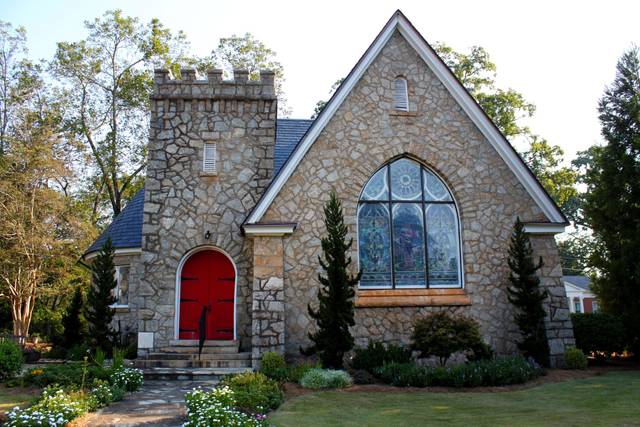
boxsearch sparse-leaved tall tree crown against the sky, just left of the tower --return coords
[51,10,184,216]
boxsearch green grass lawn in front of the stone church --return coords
[269,371,640,427]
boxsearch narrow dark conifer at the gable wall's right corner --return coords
[507,218,549,366]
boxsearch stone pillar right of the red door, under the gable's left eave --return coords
[251,236,285,368]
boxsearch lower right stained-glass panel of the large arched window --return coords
[426,204,460,287]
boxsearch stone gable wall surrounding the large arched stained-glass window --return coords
[262,33,564,362]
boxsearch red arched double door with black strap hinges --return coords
[178,250,236,340]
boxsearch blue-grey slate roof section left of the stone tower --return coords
[85,188,144,256]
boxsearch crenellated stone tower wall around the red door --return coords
[135,70,277,348]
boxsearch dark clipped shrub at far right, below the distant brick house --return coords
[571,313,625,357]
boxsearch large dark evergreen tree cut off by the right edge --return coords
[584,47,640,357]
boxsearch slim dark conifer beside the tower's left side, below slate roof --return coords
[85,238,117,351]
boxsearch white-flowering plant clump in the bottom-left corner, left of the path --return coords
[5,387,89,427]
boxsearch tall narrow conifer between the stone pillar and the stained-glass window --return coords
[307,191,360,369]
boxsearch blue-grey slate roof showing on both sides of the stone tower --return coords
[85,119,313,255]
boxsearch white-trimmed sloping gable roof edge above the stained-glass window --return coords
[245,10,568,228]
